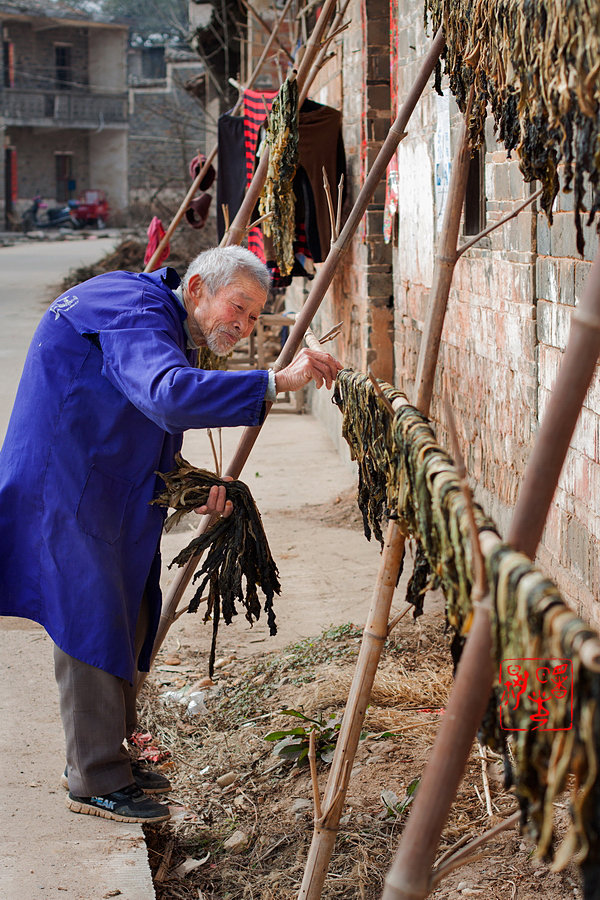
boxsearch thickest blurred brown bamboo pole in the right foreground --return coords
[383,246,600,900]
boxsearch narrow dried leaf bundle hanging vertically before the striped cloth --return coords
[258,78,298,275]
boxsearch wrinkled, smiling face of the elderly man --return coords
[184,274,267,356]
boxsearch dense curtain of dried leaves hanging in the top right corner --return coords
[425,0,600,253]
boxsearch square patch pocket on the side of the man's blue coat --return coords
[77,466,132,544]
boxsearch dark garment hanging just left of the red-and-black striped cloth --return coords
[217,113,246,242]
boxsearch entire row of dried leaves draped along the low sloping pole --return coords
[334,369,600,876]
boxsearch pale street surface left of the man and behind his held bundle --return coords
[0,238,379,900]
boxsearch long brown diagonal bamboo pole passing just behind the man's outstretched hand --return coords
[138,29,444,690]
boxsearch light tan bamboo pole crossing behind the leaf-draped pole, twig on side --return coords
[298,63,470,900]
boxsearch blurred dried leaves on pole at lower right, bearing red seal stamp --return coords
[482,544,600,880]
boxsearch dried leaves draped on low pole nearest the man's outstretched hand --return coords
[334,369,495,633]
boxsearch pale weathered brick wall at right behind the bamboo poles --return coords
[394,2,600,625]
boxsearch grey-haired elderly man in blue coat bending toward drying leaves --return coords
[0,247,340,822]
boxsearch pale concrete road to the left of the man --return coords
[0,237,154,900]
